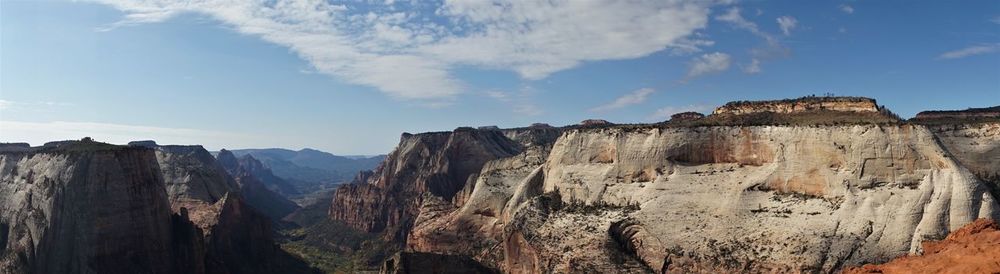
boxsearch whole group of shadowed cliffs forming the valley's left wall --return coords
[0,141,312,273]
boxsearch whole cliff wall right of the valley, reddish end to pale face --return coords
[331,118,1000,273]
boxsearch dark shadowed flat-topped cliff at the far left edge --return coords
[0,142,193,273]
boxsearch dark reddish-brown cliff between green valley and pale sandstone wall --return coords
[330,128,523,242]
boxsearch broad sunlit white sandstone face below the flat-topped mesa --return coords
[544,125,1000,272]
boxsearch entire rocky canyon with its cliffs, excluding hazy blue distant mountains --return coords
[0,97,1000,273]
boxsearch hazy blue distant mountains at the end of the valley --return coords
[231,148,385,187]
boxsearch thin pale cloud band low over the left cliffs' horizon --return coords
[0,121,264,148]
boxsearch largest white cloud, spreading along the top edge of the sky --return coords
[95,0,715,100]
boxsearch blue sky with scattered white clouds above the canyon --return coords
[0,0,1000,155]
